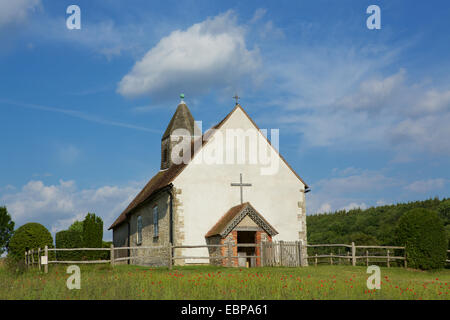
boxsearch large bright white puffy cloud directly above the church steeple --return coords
[117,11,261,97]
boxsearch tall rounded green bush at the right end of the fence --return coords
[397,208,447,270]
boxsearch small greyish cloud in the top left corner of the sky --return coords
[0,0,41,28]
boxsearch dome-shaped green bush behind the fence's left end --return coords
[8,222,53,261]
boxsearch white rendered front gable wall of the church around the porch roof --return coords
[173,108,306,263]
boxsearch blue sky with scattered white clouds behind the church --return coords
[0,0,450,239]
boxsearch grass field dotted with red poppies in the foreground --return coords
[0,265,450,300]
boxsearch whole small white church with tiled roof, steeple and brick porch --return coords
[109,100,309,266]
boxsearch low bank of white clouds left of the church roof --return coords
[0,180,140,237]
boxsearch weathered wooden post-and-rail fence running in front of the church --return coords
[25,241,450,273]
